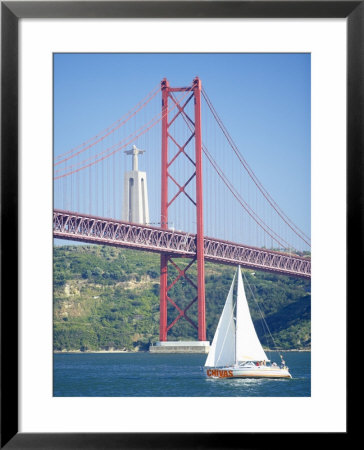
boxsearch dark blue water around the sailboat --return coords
[53,352,311,397]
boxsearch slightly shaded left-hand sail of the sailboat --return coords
[205,275,235,367]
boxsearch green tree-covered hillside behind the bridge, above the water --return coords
[53,245,311,351]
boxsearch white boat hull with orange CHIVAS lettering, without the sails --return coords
[205,366,292,378]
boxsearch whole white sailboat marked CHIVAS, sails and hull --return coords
[204,266,292,378]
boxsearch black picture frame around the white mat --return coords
[0,0,356,449]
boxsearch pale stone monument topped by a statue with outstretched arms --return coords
[122,145,150,224]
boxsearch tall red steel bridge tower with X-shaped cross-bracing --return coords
[154,77,208,352]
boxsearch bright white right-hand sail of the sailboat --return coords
[236,266,268,361]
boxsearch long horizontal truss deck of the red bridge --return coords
[53,210,311,278]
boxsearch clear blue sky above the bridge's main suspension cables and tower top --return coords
[54,54,311,250]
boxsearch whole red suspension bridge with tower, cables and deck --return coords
[53,77,311,341]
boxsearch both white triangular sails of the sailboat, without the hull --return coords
[205,266,268,367]
